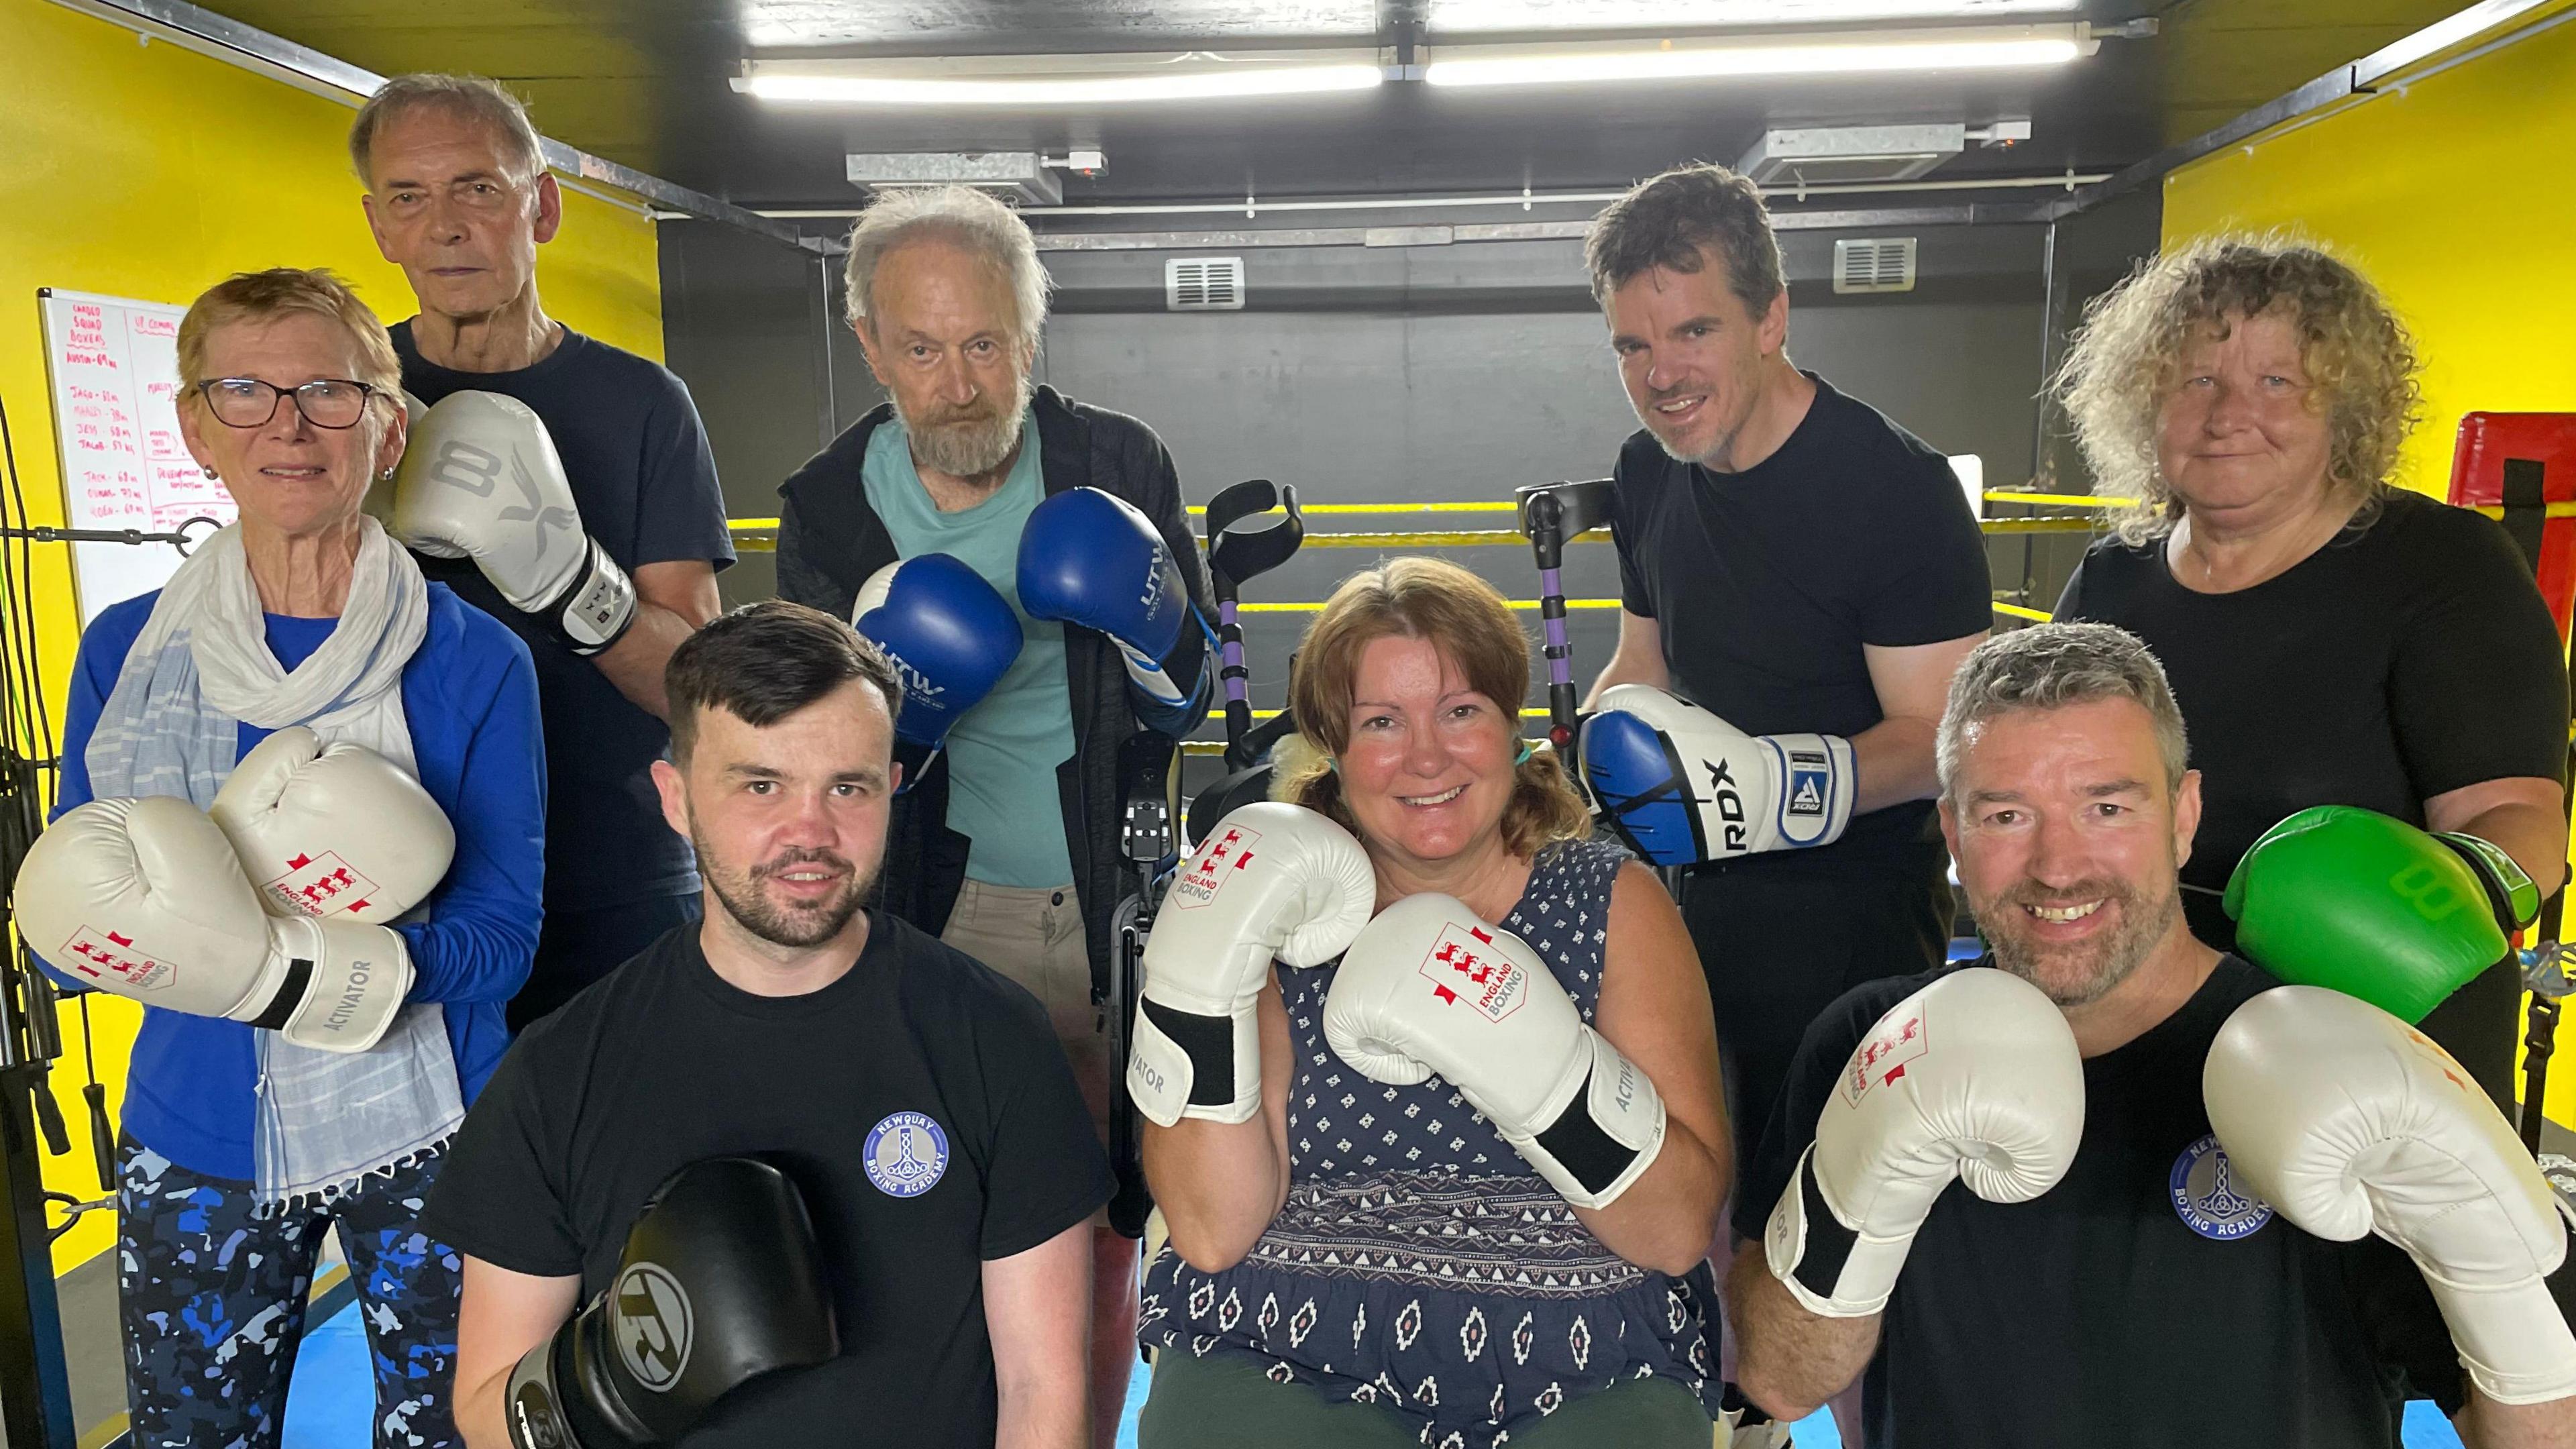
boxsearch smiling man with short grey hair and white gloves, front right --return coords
[1729,624,2576,1449]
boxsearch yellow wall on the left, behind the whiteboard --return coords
[0,0,662,1269]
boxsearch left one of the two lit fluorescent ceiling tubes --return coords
[734,49,1386,106]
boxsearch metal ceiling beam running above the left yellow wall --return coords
[54,0,843,255]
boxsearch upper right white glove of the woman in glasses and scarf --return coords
[209,724,456,926]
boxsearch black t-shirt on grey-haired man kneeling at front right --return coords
[1736,957,2576,1449]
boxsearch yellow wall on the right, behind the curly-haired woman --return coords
[2164,8,2576,1127]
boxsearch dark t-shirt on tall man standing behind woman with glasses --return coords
[394,322,734,910]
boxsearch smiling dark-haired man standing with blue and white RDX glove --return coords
[1585,165,1991,1185]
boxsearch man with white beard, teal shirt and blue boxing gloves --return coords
[778,189,1214,1449]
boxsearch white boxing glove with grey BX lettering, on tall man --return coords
[394,392,636,655]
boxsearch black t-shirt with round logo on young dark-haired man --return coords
[423,910,1110,1449]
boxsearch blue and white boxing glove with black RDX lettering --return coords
[1579,684,1858,866]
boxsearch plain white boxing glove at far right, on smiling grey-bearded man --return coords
[2200,985,2576,1403]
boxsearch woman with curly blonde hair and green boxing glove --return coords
[2055,235,2568,1093]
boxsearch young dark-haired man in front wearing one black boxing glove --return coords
[425,601,1110,1449]
